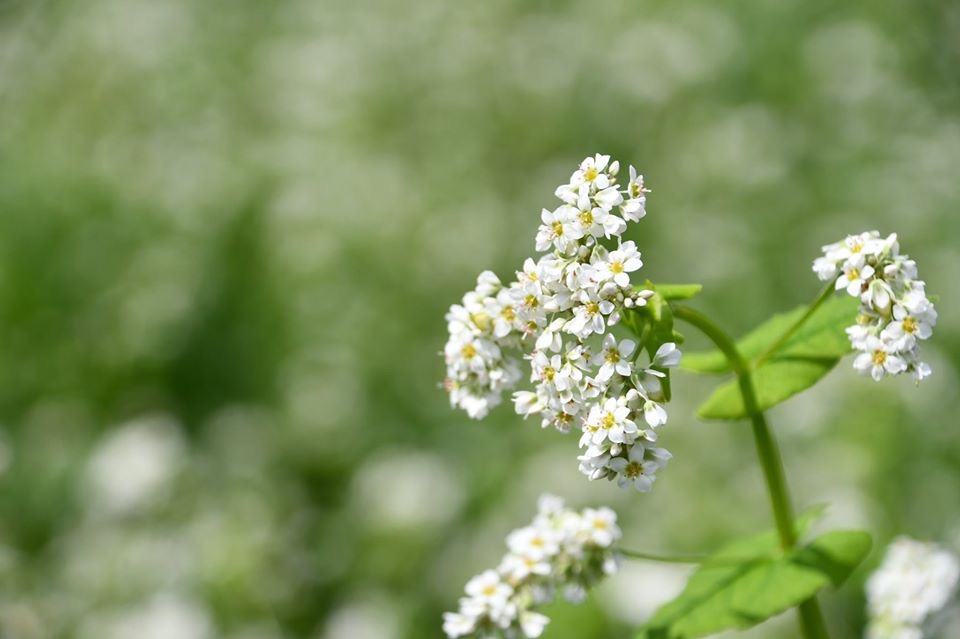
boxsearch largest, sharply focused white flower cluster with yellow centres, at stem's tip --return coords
[444,155,680,491]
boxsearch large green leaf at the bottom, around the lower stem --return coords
[639,531,871,639]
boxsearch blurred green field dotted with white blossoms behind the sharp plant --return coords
[0,0,960,639]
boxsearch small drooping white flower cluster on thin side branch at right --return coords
[813,231,937,381]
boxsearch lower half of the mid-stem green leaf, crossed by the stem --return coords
[697,358,840,419]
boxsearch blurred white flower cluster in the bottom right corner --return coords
[866,537,960,639]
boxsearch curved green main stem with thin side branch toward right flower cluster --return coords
[673,304,828,639]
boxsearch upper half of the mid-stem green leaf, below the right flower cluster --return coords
[680,296,857,373]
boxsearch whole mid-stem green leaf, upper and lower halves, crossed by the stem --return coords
[681,296,856,420]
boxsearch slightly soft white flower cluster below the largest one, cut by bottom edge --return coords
[443,495,620,639]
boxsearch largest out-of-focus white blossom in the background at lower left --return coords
[87,415,184,514]
